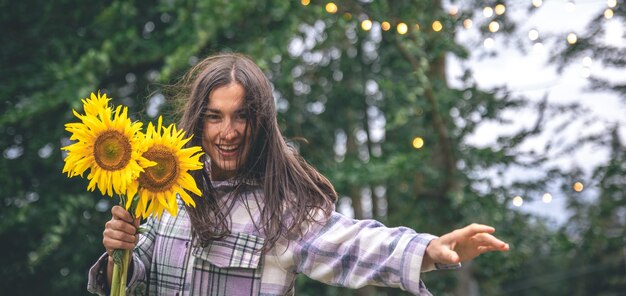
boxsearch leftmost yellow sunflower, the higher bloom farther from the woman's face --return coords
[61,93,154,199]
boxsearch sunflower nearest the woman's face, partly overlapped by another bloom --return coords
[135,117,203,217]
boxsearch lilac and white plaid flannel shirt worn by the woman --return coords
[88,181,448,295]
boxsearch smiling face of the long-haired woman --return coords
[202,83,250,181]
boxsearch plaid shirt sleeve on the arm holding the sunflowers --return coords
[87,218,155,296]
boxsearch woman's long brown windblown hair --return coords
[173,53,337,250]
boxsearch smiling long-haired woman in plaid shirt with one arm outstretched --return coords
[88,54,508,295]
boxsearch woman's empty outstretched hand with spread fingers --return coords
[422,223,509,266]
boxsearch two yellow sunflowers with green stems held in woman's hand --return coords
[61,92,203,295]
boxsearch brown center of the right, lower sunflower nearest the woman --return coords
[139,146,178,192]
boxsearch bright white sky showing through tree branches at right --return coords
[448,0,626,222]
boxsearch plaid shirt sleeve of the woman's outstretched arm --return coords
[290,212,436,295]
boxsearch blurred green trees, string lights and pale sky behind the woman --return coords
[0,0,626,295]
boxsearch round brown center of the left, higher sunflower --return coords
[93,131,133,171]
